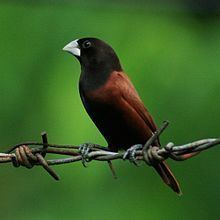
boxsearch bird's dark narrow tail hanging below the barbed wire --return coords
[153,161,182,195]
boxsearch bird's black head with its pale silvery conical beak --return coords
[63,38,122,75]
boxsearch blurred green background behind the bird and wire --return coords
[0,0,220,220]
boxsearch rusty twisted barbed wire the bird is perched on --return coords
[0,121,220,180]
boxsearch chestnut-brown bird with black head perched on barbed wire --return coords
[63,37,181,194]
